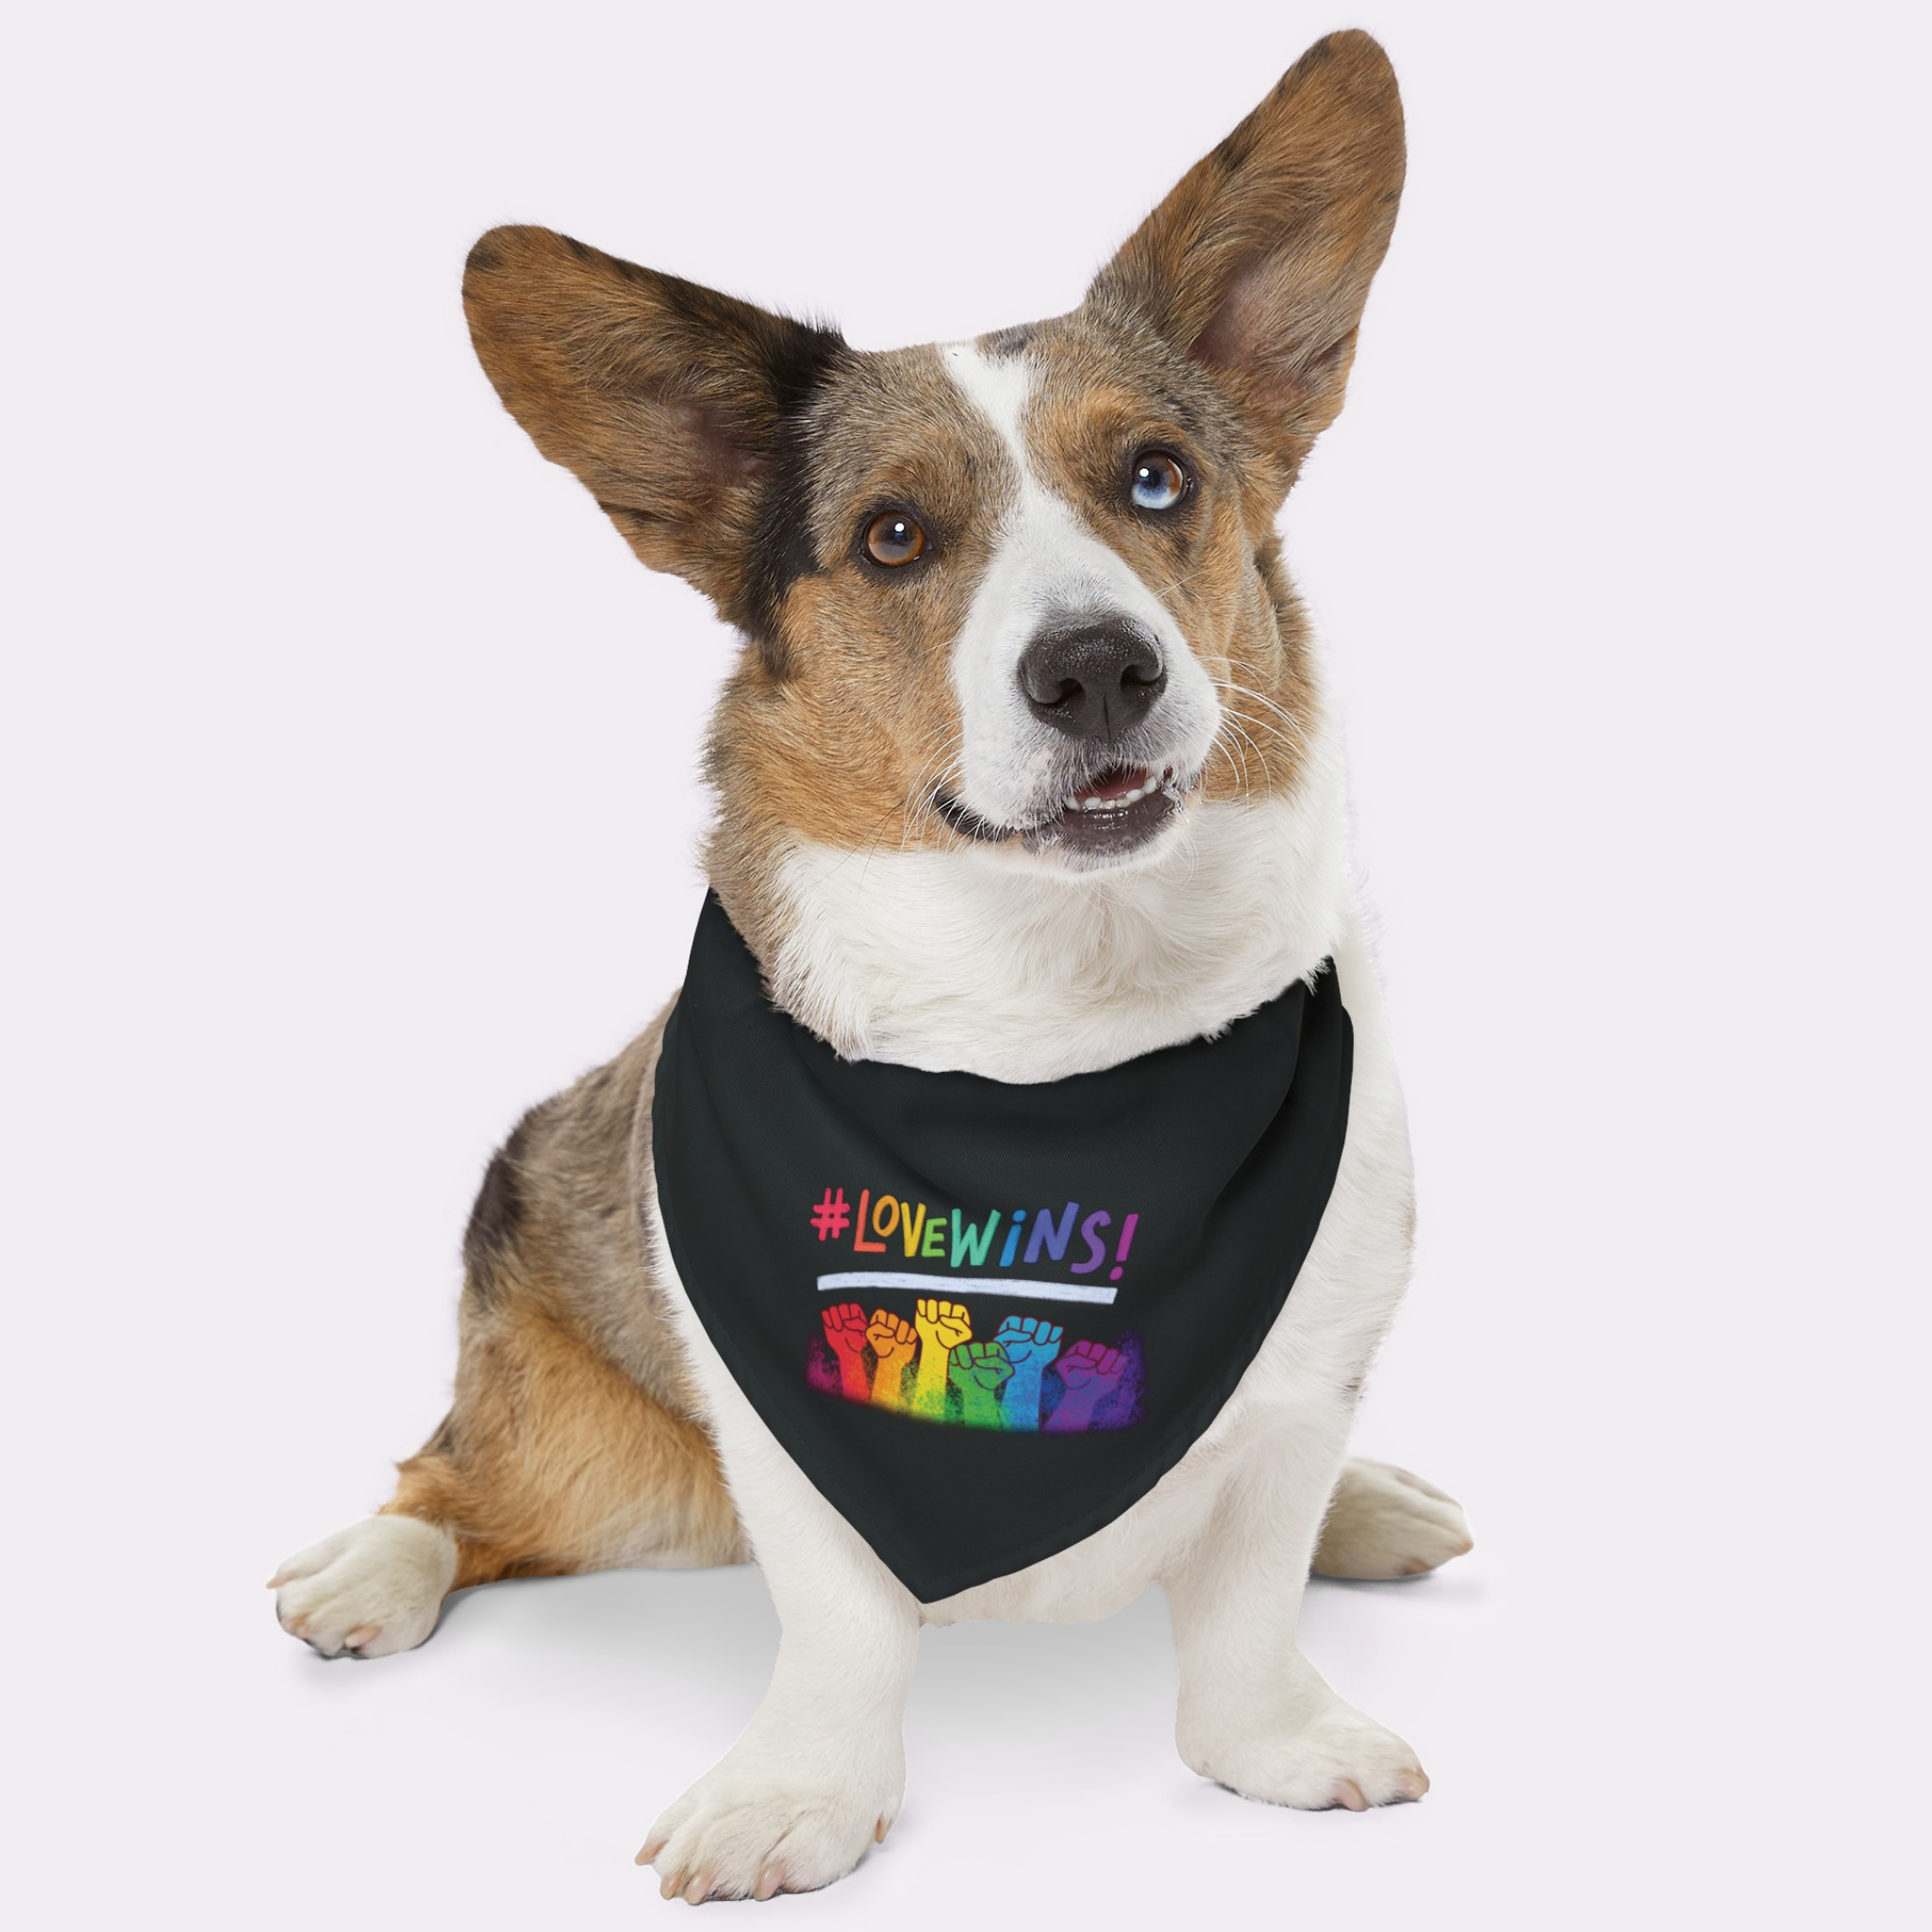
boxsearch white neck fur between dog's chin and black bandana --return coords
[773,769,1351,1082]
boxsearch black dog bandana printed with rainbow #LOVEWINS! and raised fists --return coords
[653,896,1353,1604]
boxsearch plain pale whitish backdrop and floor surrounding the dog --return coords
[0,0,1932,1932]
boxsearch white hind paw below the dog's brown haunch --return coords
[269,1517,456,1657]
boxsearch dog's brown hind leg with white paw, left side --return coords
[273,1028,746,1657]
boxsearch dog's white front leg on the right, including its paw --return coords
[1163,1412,1430,1810]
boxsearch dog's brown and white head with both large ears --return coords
[464,33,1403,900]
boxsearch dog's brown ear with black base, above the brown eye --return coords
[464,228,846,630]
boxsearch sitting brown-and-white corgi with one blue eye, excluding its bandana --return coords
[271,33,1471,1903]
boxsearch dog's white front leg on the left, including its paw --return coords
[638,1397,920,1905]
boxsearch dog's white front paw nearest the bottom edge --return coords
[638,1753,904,1905]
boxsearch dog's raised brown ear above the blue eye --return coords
[1088,33,1403,487]
